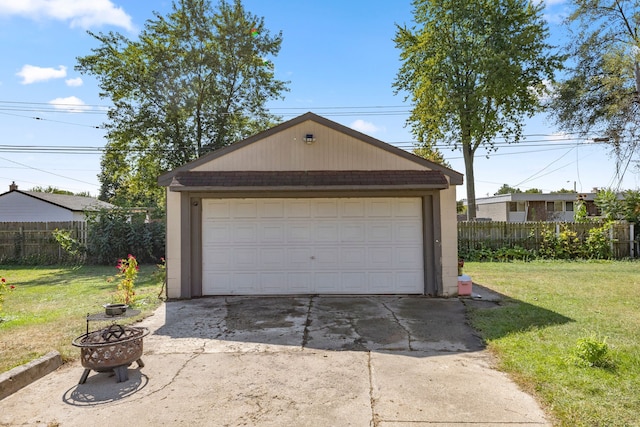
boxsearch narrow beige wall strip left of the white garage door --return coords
[166,188,182,298]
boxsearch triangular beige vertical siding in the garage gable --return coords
[193,121,425,171]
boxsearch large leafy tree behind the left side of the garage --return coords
[76,0,287,211]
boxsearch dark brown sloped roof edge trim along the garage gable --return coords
[158,112,462,186]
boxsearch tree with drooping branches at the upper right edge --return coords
[550,0,640,182]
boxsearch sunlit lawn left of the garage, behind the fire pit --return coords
[0,266,161,372]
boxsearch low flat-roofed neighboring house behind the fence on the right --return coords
[465,193,598,222]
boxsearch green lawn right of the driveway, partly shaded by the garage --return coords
[465,261,640,426]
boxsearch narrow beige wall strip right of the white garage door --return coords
[436,186,458,297]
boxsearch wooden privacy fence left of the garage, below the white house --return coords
[0,221,87,263]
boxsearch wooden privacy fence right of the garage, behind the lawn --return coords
[458,221,638,259]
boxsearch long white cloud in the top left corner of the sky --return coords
[0,0,134,31]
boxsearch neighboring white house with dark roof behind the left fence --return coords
[0,183,115,222]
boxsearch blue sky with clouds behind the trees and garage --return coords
[0,0,640,199]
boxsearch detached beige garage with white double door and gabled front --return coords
[158,113,462,298]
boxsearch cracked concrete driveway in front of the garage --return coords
[0,296,550,426]
